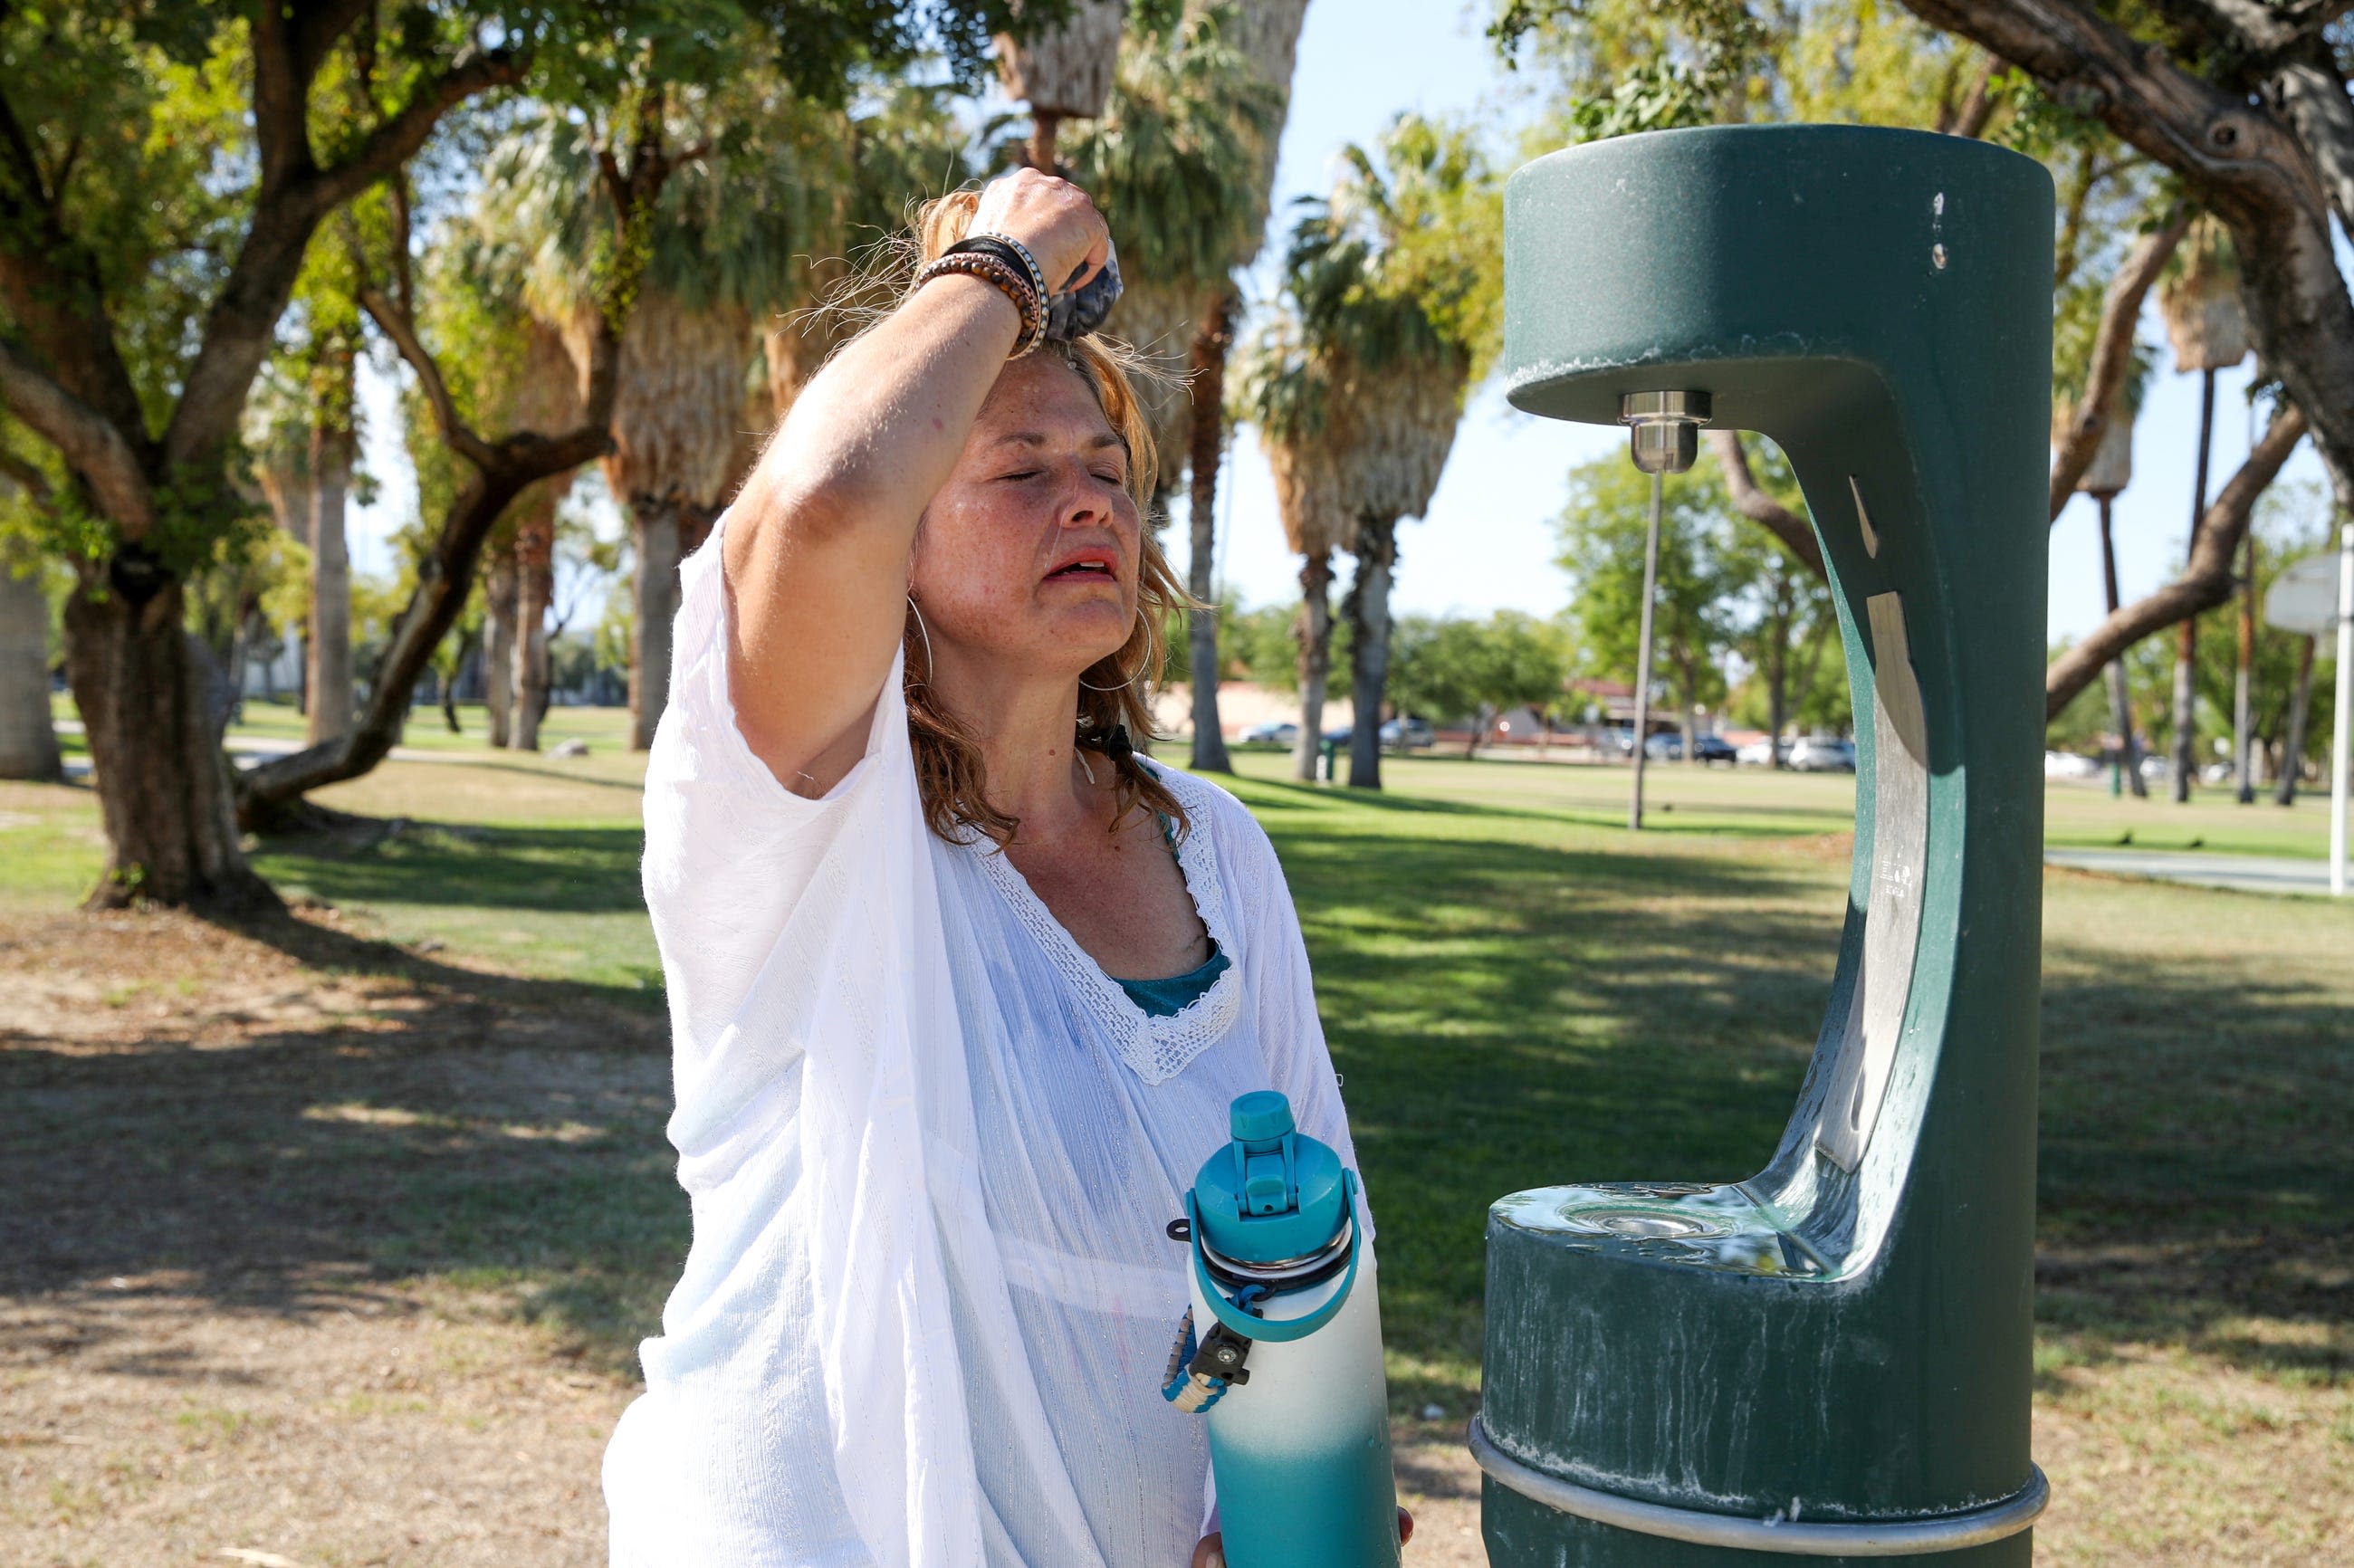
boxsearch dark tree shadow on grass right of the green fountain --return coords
[2036,944,2354,1380]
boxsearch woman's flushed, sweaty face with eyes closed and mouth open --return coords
[909,353,1142,675]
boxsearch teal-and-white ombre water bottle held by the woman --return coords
[1163,1090,1398,1568]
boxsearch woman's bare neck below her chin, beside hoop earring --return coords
[933,659,1111,843]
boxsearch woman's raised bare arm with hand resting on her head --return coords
[721,169,1109,796]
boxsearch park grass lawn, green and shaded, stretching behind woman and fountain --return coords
[0,734,2354,1563]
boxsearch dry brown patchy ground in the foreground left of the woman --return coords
[0,911,1483,1568]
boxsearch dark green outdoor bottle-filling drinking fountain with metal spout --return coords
[1471,125,2053,1568]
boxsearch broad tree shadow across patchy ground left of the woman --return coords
[0,899,687,1372]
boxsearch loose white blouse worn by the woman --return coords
[605,518,1356,1568]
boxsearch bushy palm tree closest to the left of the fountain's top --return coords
[1286,115,1502,789]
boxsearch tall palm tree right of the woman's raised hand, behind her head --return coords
[1068,7,1283,772]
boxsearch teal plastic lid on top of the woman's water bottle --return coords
[1193,1090,1349,1262]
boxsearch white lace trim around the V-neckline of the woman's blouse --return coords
[965,768,1243,1083]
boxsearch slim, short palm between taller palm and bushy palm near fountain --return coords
[1233,309,1351,781]
